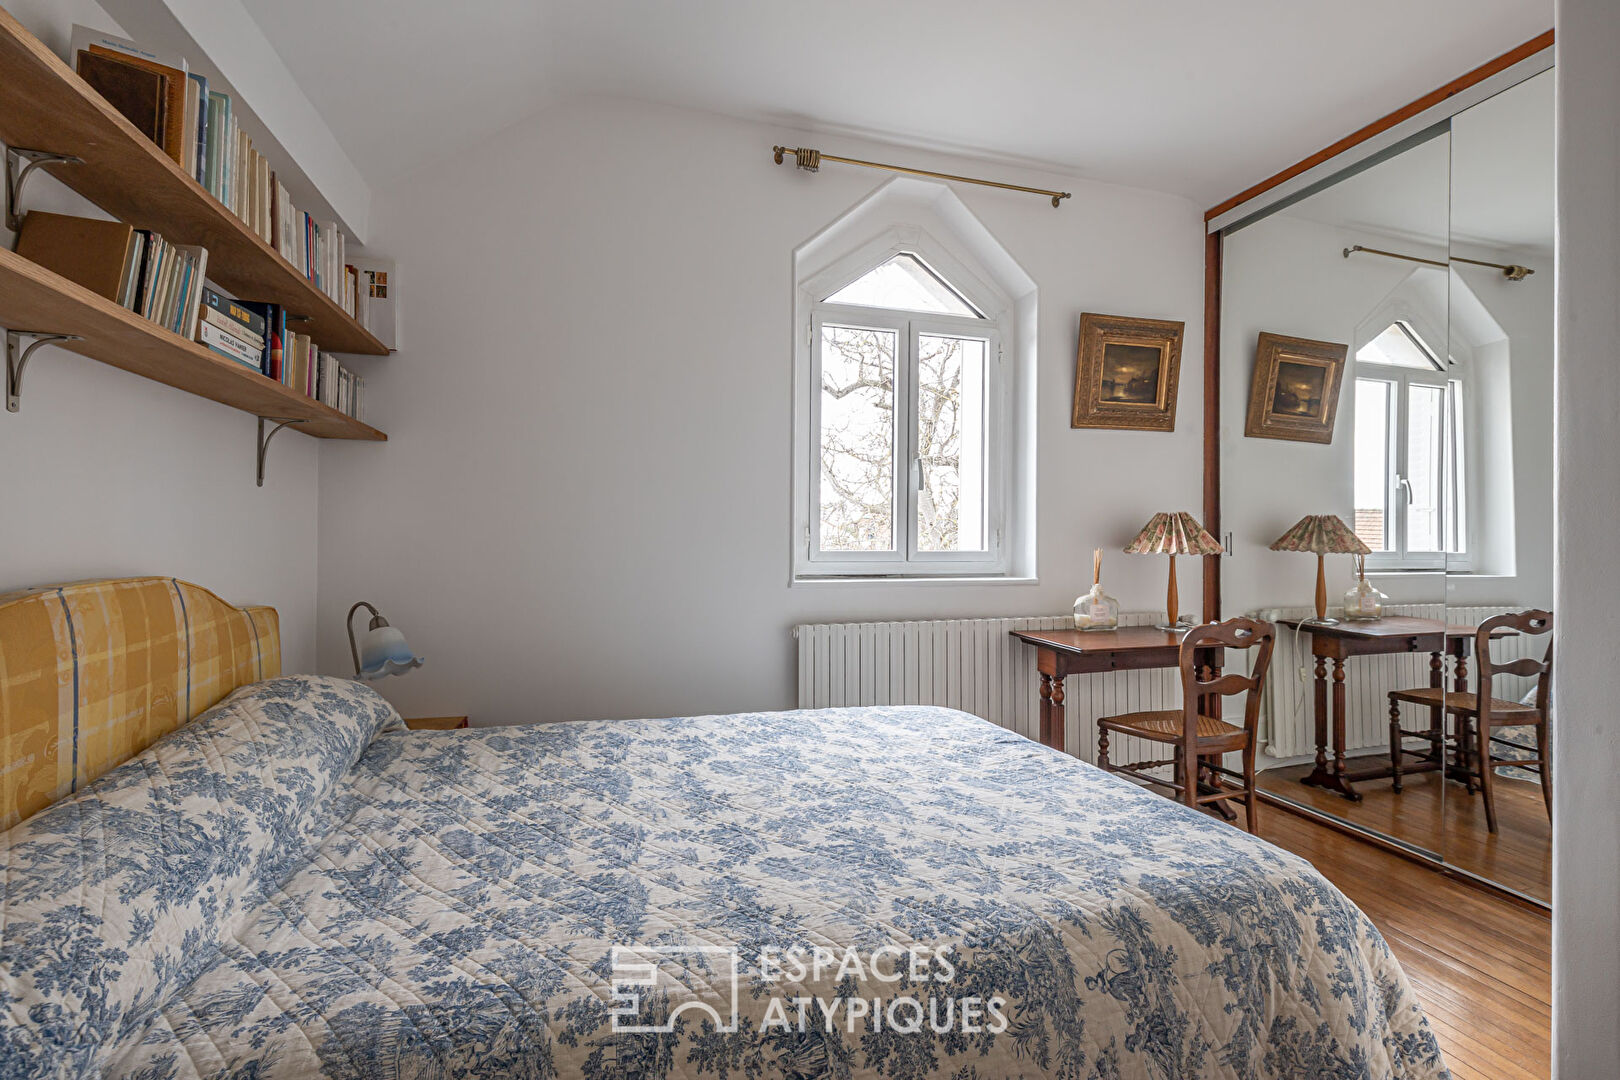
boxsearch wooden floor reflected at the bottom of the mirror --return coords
[1256,766,1552,902]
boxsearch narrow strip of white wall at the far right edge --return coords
[1552,0,1620,1080]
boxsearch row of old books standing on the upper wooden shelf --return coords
[71,26,361,319]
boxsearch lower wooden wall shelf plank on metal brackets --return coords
[0,248,387,442]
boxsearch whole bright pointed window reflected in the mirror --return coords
[1354,321,1468,570]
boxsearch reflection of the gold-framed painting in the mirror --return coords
[1243,334,1349,442]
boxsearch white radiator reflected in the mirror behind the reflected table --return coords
[1257,604,1547,758]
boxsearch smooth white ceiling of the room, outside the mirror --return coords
[245,0,1552,204]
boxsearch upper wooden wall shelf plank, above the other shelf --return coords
[0,8,389,356]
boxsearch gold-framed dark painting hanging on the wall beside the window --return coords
[1069,313,1187,431]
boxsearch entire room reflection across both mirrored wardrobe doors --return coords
[1220,71,1554,902]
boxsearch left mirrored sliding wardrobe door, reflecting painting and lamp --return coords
[1220,123,1461,858]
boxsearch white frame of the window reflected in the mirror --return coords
[1351,319,1474,572]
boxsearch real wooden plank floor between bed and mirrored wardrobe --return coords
[1260,806,1552,1080]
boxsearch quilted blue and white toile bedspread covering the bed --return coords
[0,677,1448,1080]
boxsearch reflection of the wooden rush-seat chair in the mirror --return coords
[1390,609,1552,832]
